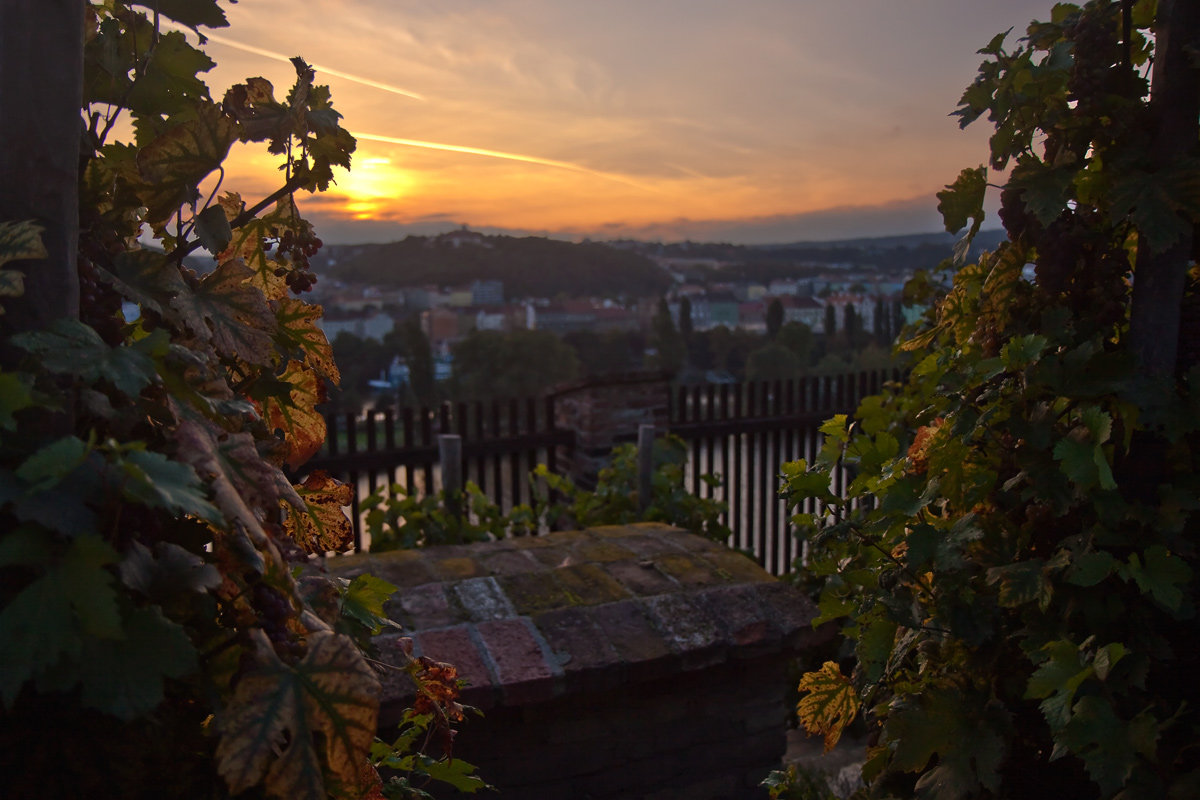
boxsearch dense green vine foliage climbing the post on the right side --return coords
[785,2,1200,800]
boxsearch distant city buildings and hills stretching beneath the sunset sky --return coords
[312,228,1002,407]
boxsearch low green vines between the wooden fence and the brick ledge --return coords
[362,435,731,552]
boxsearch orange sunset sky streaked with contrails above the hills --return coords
[182,0,1050,242]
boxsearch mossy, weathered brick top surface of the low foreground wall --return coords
[328,523,823,722]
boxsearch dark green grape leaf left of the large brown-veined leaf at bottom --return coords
[79,606,197,720]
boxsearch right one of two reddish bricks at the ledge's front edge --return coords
[476,616,563,705]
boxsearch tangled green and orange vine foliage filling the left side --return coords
[0,0,478,800]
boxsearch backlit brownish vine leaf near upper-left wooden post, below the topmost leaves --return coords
[138,103,238,224]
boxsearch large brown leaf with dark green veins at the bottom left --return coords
[216,631,379,800]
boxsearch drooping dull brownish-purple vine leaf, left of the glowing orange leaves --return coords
[172,260,275,366]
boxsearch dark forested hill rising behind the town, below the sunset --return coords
[322,236,671,299]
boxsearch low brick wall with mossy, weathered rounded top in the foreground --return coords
[331,524,823,800]
